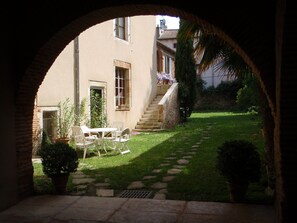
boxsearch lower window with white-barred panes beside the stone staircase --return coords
[115,67,130,110]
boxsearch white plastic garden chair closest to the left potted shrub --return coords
[72,126,101,159]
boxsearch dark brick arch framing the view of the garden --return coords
[15,2,275,202]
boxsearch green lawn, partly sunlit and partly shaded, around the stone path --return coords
[34,112,273,203]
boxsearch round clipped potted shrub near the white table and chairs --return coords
[40,142,79,194]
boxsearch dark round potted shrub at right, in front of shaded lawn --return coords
[216,140,261,202]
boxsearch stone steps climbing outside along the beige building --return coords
[134,94,164,132]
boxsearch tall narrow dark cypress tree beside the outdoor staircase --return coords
[175,19,197,121]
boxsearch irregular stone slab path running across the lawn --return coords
[72,123,212,200]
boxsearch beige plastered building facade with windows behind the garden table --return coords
[35,16,157,138]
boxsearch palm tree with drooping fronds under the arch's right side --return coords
[178,18,274,190]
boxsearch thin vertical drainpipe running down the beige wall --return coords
[73,37,80,125]
